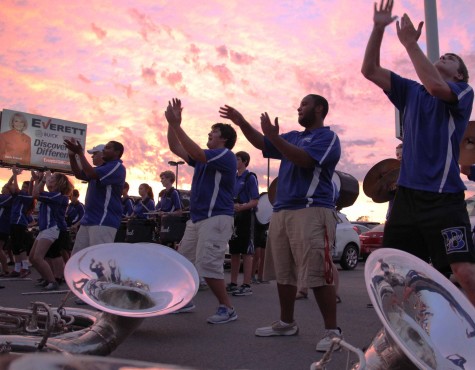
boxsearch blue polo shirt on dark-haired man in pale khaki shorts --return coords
[187,148,237,222]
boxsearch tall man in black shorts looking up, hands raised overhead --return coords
[361,0,475,305]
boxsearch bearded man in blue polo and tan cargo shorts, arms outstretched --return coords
[219,94,342,352]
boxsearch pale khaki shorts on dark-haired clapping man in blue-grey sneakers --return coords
[178,215,234,279]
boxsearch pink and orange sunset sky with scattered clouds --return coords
[0,0,475,221]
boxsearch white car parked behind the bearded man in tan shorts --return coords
[333,212,360,270]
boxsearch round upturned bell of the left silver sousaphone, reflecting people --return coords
[64,243,199,317]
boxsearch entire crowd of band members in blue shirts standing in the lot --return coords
[0,0,475,358]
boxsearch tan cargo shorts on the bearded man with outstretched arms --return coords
[264,207,337,288]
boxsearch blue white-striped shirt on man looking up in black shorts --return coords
[386,73,474,193]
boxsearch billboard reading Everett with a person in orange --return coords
[0,109,87,172]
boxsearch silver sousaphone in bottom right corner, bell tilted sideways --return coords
[312,248,475,370]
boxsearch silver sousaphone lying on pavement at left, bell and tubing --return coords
[0,243,199,356]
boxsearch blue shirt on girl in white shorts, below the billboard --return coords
[38,191,69,231]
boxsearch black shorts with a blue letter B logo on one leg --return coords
[383,187,475,274]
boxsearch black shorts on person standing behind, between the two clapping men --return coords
[229,210,255,254]
